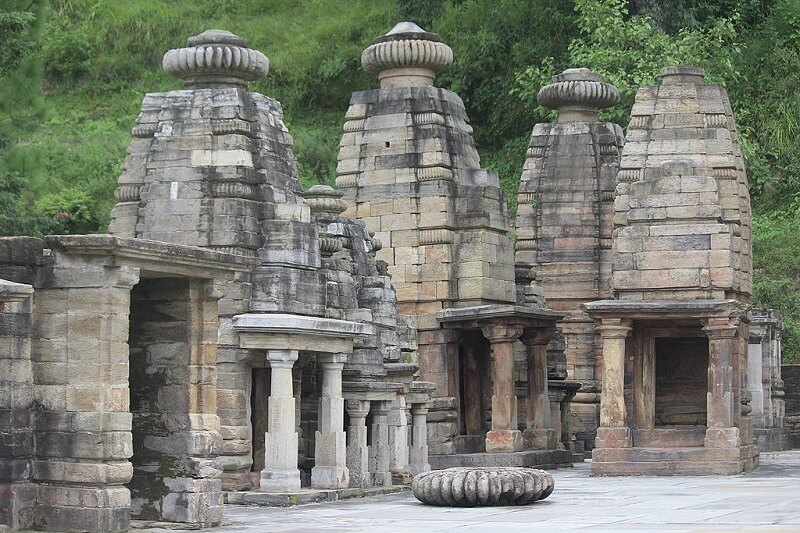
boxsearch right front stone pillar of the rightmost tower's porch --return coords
[703,318,739,448]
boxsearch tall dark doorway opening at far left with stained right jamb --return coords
[127,278,221,523]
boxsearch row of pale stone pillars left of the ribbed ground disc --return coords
[260,350,430,492]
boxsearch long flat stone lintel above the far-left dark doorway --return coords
[45,234,258,280]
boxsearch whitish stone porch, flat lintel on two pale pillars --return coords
[233,313,373,493]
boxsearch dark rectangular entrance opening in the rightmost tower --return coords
[654,337,708,427]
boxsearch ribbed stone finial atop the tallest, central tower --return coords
[361,22,453,89]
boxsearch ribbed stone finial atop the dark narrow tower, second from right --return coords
[536,68,619,122]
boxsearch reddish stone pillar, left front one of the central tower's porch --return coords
[483,324,522,452]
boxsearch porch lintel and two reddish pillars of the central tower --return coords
[438,305,563,452]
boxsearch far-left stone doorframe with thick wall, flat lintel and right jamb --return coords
[32,235,256,532]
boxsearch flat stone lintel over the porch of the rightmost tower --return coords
[582,299,750,320]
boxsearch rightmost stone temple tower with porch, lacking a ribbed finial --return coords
[584,66,758,475]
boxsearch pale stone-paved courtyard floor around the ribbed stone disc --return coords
[138,450,800,533]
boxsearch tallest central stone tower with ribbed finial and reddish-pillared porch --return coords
[336,22,571,466]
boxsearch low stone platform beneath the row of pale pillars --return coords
[224,485,411,507]
